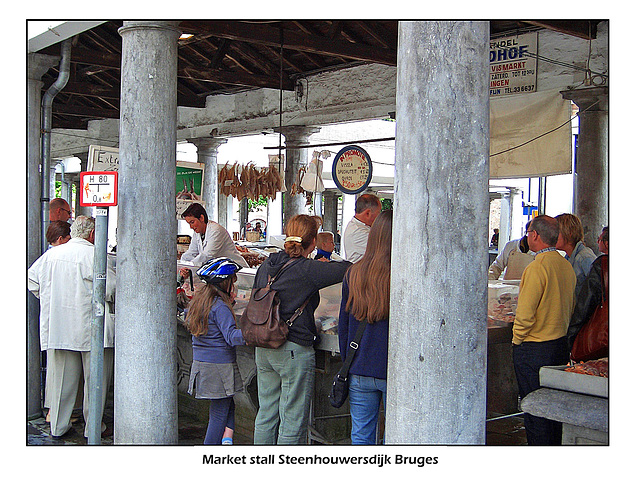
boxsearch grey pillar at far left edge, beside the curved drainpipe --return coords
[27,53,60,419]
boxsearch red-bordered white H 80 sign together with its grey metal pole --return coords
[80,172,118,445]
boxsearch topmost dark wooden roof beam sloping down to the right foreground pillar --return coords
[180,21,396,65]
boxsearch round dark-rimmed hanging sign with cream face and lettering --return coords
[331,145,373,194]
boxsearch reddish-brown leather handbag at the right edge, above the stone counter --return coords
[571,256,609,362]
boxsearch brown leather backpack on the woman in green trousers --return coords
[237,258,309,348]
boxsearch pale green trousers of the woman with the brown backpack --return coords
[253,341,315,445]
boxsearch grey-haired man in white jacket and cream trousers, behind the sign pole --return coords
[29,216,115,437]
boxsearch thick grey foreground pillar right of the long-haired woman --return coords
[385,21,489,444]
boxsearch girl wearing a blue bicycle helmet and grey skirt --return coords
[186,257,246,445]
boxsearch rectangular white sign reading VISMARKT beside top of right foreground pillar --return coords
[489,32,538,97]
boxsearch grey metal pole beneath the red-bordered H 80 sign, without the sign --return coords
[87,207,109,445]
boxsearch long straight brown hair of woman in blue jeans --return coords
[346,210,393,323]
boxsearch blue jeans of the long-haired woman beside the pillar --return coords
[349,375,387,445]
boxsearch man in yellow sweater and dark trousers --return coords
[512,215,576,445]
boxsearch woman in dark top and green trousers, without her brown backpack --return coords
[253,215,351,445]
